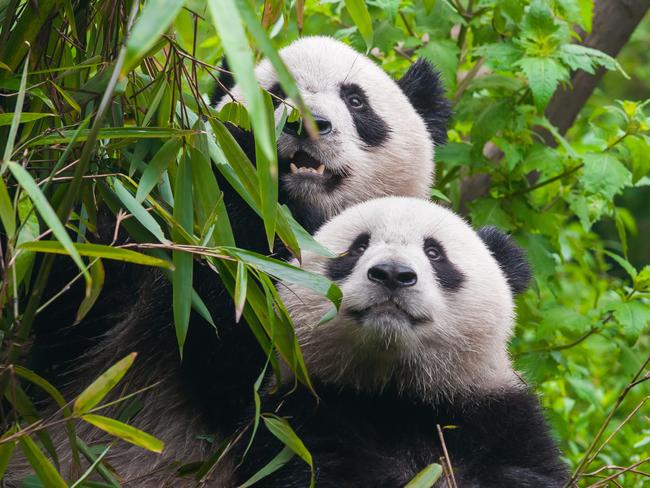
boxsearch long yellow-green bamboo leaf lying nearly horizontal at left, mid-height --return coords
[18,241,174,269]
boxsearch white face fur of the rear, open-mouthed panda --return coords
[217,36,433,218]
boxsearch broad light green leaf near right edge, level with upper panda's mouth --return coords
[580,154,632,200]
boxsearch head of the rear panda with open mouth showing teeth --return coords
[212,37,450,228]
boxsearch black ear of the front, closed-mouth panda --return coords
[478,226,532,295]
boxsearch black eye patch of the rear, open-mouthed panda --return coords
[340,83,390,147]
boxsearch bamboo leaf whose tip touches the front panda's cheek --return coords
[220,247,343,309]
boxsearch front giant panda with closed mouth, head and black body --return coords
[228,197,567,488]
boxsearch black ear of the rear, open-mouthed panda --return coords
[397,58,451,146]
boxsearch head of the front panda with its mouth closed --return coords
[279,197,530,402]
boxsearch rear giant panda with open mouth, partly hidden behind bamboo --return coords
[13,37,450,487]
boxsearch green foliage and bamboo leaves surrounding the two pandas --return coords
[0,0,650,487]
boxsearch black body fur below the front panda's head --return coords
[235,384,567,488]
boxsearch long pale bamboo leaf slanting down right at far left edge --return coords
[7,161,91,286]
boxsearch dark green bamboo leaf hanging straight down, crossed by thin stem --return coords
[172,153,194,357]
